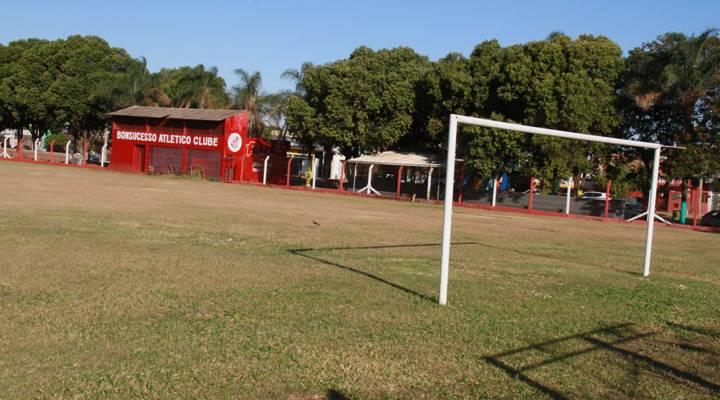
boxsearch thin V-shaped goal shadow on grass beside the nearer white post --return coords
[288,242,477,303]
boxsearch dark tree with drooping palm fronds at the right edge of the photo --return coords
[619,29,720,203]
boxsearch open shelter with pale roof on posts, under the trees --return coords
[347,151,445,200]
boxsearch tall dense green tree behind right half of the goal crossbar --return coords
[525,33,624,192]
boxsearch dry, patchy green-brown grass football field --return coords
[0,162,720,399]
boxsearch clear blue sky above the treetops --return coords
[0,0,720,92]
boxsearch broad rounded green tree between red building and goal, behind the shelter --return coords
[288,47,430,152]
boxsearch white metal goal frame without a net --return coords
[438,114,663,305]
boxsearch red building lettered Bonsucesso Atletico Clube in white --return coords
[110,106,285,182]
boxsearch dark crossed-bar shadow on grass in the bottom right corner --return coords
[482,323,720,399]
